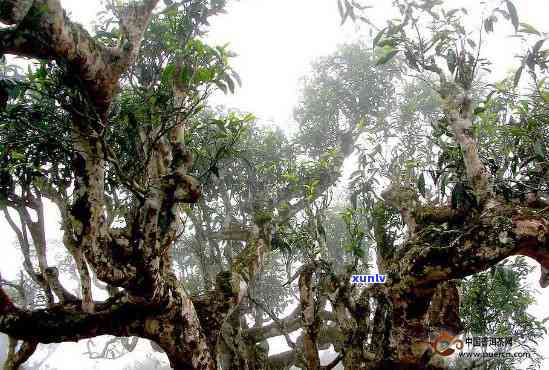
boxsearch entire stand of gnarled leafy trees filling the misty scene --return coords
[0,0,549,369]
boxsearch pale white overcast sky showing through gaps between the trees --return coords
[0,0,549,370]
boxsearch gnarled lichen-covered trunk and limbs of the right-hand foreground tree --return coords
[368,74,549,369]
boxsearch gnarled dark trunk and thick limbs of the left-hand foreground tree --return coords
[0,0,216,369]
